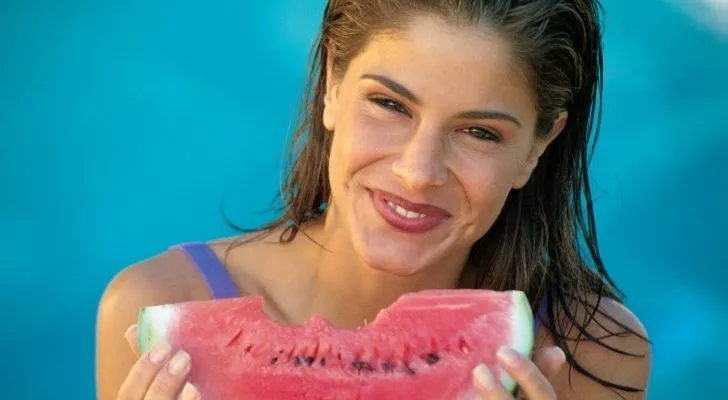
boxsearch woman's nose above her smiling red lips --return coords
[392,129,448,191]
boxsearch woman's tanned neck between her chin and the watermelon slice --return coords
[300,212,464,328]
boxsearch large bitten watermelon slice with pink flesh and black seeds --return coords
[139,290,533,400]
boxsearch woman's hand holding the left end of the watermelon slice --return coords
[117,325,200,400]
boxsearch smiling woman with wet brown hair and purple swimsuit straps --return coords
[97,0,650,400]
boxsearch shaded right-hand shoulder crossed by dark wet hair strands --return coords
[554,296,652,400]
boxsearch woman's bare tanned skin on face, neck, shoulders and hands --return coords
[97,18,651,400]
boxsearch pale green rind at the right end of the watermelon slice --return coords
[500,291,534,393]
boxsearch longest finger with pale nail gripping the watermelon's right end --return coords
[498,348,556,400]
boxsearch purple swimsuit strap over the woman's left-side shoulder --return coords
[175,243,240,299]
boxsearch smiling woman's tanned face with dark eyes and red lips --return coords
[323,17,564,276]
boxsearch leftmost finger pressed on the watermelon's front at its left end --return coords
[118,342,172,400]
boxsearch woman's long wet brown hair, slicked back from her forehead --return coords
[226,0,647,392]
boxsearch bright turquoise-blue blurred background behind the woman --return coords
[0,0,728,399]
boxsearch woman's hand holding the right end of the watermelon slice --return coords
[473,347,566,400]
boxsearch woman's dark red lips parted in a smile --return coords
[370,190,450,233]
